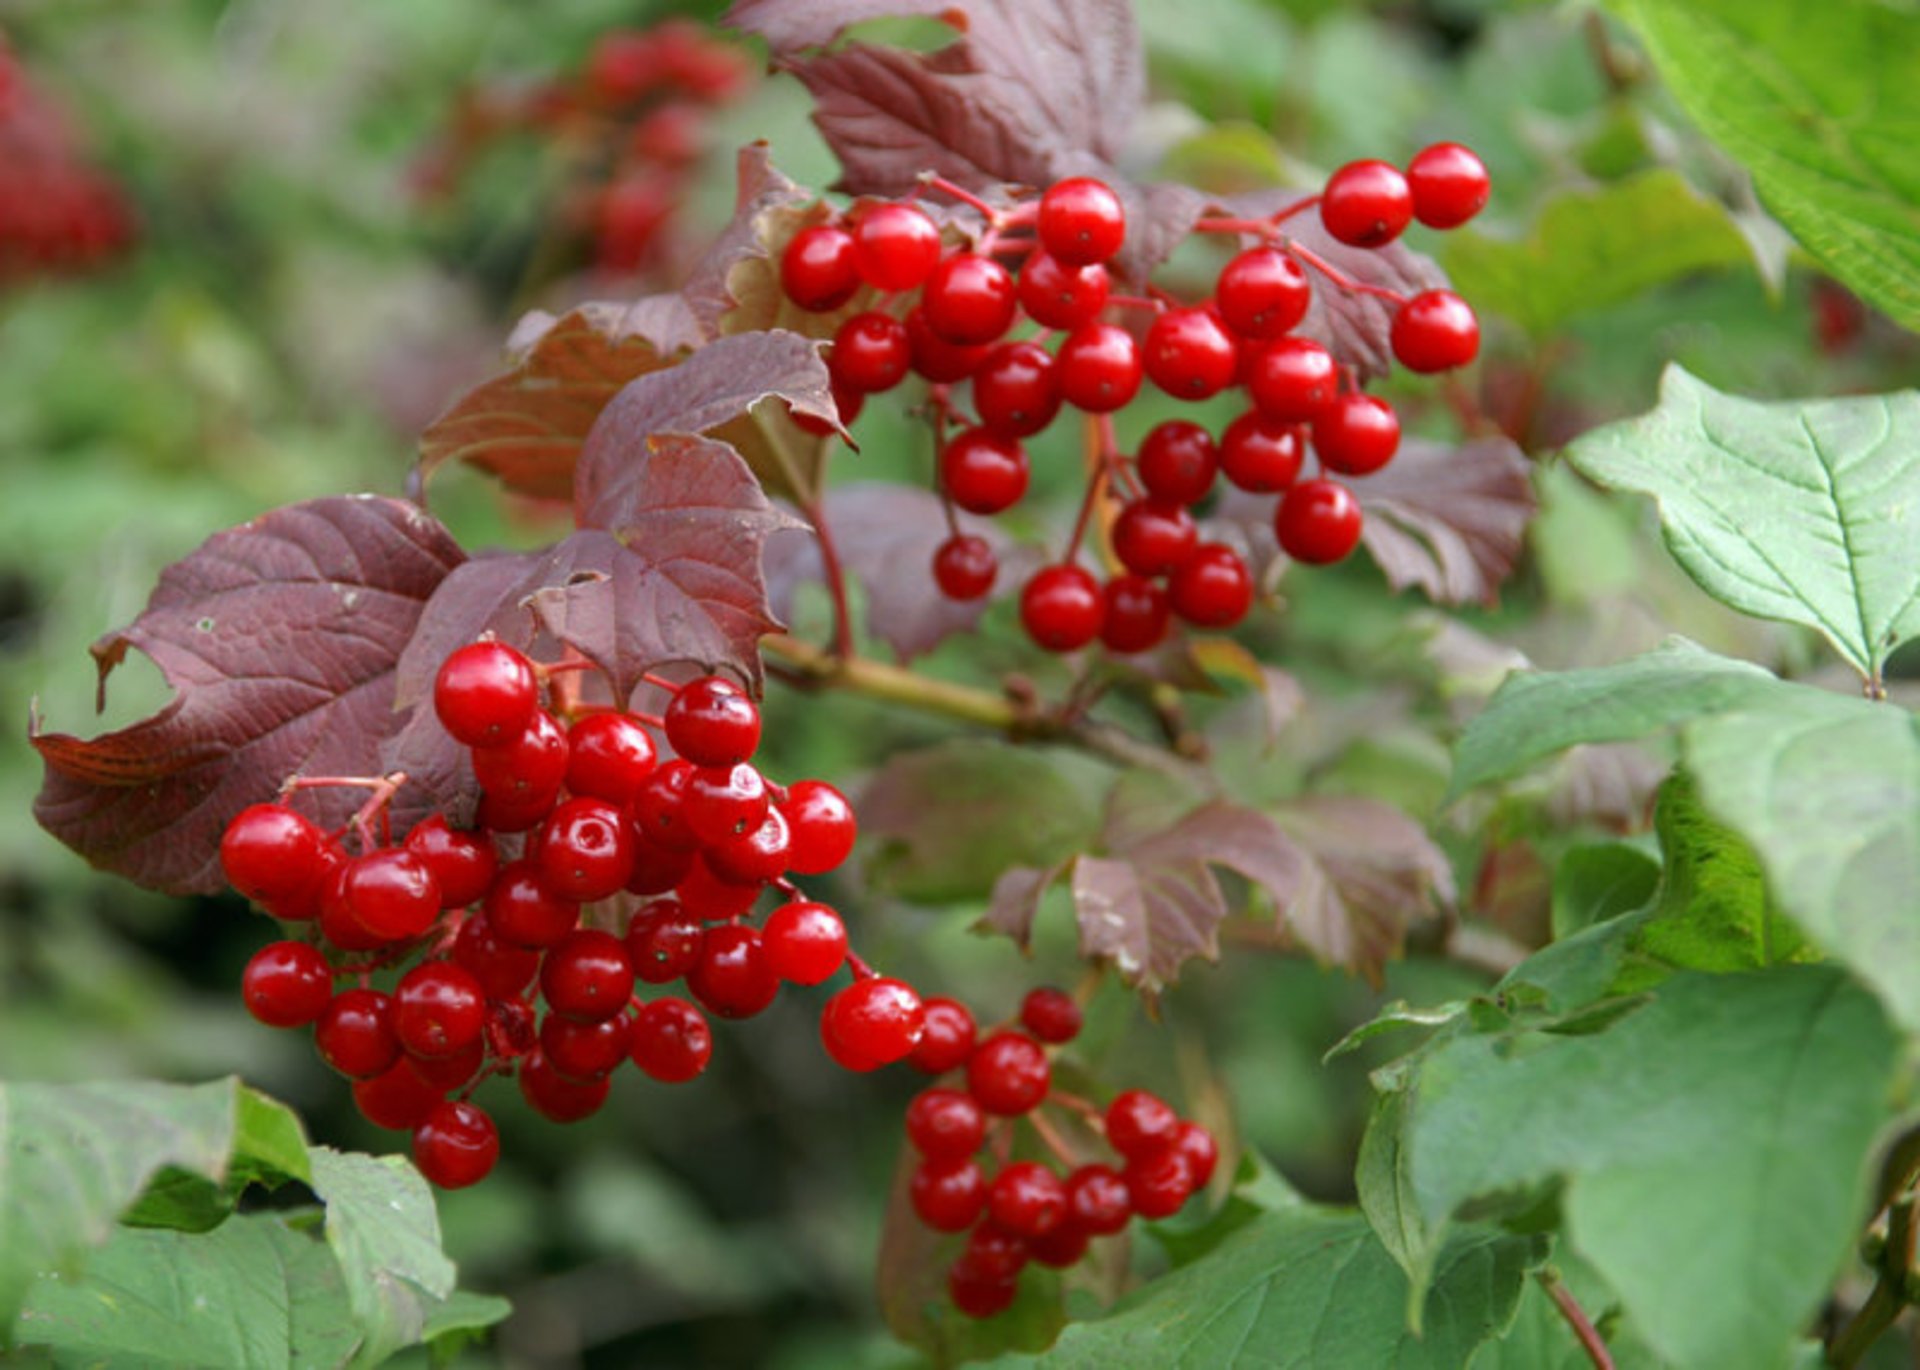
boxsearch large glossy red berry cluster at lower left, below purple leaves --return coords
[221,639,864,1188]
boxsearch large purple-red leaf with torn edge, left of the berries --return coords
[33,497,461,894]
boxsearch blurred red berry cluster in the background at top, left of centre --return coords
[417,19,749,274]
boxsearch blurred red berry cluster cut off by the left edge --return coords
[0,44,132,282]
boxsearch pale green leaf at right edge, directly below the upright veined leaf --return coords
[1684,687,1920,1030]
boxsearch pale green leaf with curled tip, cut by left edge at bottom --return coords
[0,1078,305,1330]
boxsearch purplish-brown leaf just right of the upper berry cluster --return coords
[1352,437,1534,604]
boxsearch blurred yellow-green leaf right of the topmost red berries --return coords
[1442,167,1749,338]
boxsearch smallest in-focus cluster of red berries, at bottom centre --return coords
[906,988,1219,1318]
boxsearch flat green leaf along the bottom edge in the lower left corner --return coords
[19,1213,359,1370]
